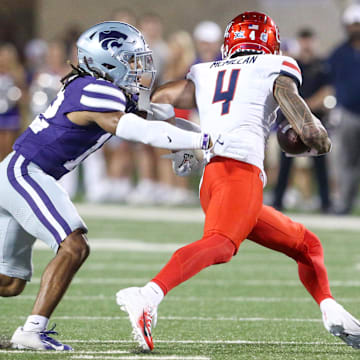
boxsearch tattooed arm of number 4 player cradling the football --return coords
[274,75,331,154]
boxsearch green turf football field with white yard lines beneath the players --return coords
[0,210,360,360]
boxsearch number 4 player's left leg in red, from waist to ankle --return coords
[152,157,263,294]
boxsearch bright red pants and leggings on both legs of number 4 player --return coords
[153,158,332,304]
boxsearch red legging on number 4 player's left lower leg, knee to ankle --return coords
[152,234,236,295]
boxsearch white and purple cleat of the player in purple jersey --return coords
[10,325,73,351]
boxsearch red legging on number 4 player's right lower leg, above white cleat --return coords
[296,230,332,304]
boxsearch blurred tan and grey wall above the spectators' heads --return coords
[0,0,351,51]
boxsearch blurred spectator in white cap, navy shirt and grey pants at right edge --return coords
[329,4,360,214]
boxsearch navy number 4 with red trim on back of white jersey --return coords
[213,69,240,115]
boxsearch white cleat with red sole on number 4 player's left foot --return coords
[116,287,157,351]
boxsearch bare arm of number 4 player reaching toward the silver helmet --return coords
[151,80,196,109]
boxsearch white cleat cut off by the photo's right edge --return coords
[321,299,360,349]
